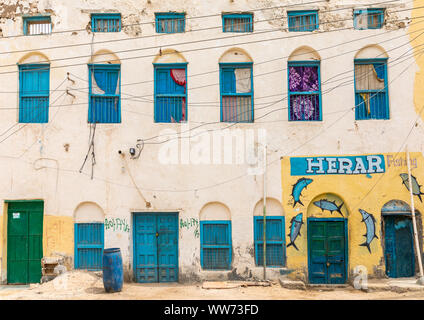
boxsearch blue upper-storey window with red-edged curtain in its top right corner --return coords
[154,63,187,122]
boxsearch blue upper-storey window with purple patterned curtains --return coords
[288,61,322,121]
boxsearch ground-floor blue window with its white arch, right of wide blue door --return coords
[200,202,232,270]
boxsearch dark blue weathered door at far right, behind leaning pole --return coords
[384,215,415,278]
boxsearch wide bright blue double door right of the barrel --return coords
[134,213,178,282]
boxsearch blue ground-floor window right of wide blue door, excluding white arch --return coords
[200,220,231,270]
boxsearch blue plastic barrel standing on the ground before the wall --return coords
[103,248,124,292]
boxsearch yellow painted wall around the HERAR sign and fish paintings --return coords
[281,152,424,278]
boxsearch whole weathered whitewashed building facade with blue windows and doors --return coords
[0,0,424,283]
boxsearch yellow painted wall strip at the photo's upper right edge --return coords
[408,0,424,120]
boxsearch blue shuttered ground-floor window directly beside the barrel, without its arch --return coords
[75,223,104,271]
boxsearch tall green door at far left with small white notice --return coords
[7,200,44,284]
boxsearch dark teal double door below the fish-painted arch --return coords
[308,218,347,284]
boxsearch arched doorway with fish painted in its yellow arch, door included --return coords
[307,193,348,284]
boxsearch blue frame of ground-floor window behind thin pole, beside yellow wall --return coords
[253,216,286,268]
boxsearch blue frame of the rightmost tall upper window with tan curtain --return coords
[354,58,390,120]
